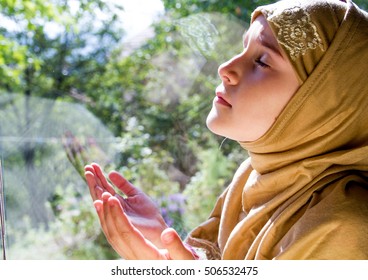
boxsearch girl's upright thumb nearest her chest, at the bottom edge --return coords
[161,228,194,260]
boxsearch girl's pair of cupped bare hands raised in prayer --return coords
[85,163,196,260]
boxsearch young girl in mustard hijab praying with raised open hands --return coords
[85,0,368,259]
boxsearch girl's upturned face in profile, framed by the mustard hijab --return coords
[207,16,300,142]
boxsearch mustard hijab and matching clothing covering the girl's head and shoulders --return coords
[187,0,368,259]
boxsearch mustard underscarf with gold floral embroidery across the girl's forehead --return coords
[252,0,346,82]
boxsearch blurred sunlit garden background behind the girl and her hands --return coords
[0,0,368,260]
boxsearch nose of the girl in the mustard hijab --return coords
[218,53,244,86]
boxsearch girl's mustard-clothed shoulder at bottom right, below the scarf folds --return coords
[280,183,368,259]
